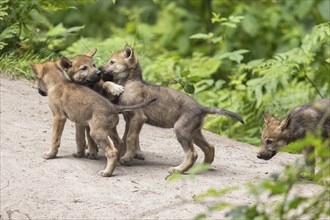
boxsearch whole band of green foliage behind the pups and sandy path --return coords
[0,0,330,145]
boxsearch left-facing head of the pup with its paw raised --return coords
[101,46,142,84]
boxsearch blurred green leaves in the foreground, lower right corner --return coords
[194,135,330,220]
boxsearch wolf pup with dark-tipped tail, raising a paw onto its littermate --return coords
[100,46,244,173]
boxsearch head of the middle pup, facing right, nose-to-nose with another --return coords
[60,49,101,85]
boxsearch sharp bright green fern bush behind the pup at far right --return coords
[191,19,330,144]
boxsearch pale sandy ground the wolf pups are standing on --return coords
[0,75,320,220]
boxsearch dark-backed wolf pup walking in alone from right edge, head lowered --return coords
[257,99,330,167]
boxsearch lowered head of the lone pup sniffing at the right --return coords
[257,112,290,160]
